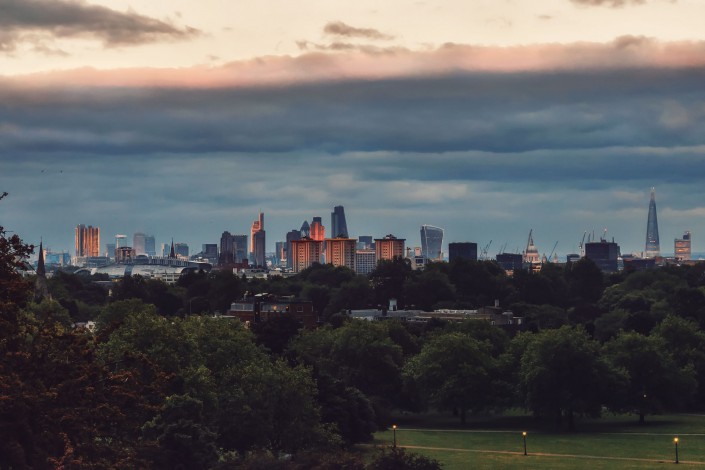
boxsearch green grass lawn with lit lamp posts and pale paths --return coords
[375,415,705,470]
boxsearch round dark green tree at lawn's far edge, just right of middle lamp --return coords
[520,326,615,431]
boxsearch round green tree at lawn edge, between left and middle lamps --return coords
[404,333,497,424]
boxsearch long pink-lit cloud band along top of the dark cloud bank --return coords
[5,36,705,88]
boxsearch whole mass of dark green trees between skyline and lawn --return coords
[0,222,705,469]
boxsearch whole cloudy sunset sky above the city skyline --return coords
[0,0,705,258]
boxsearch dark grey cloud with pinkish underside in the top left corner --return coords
[0,0,199,51]
